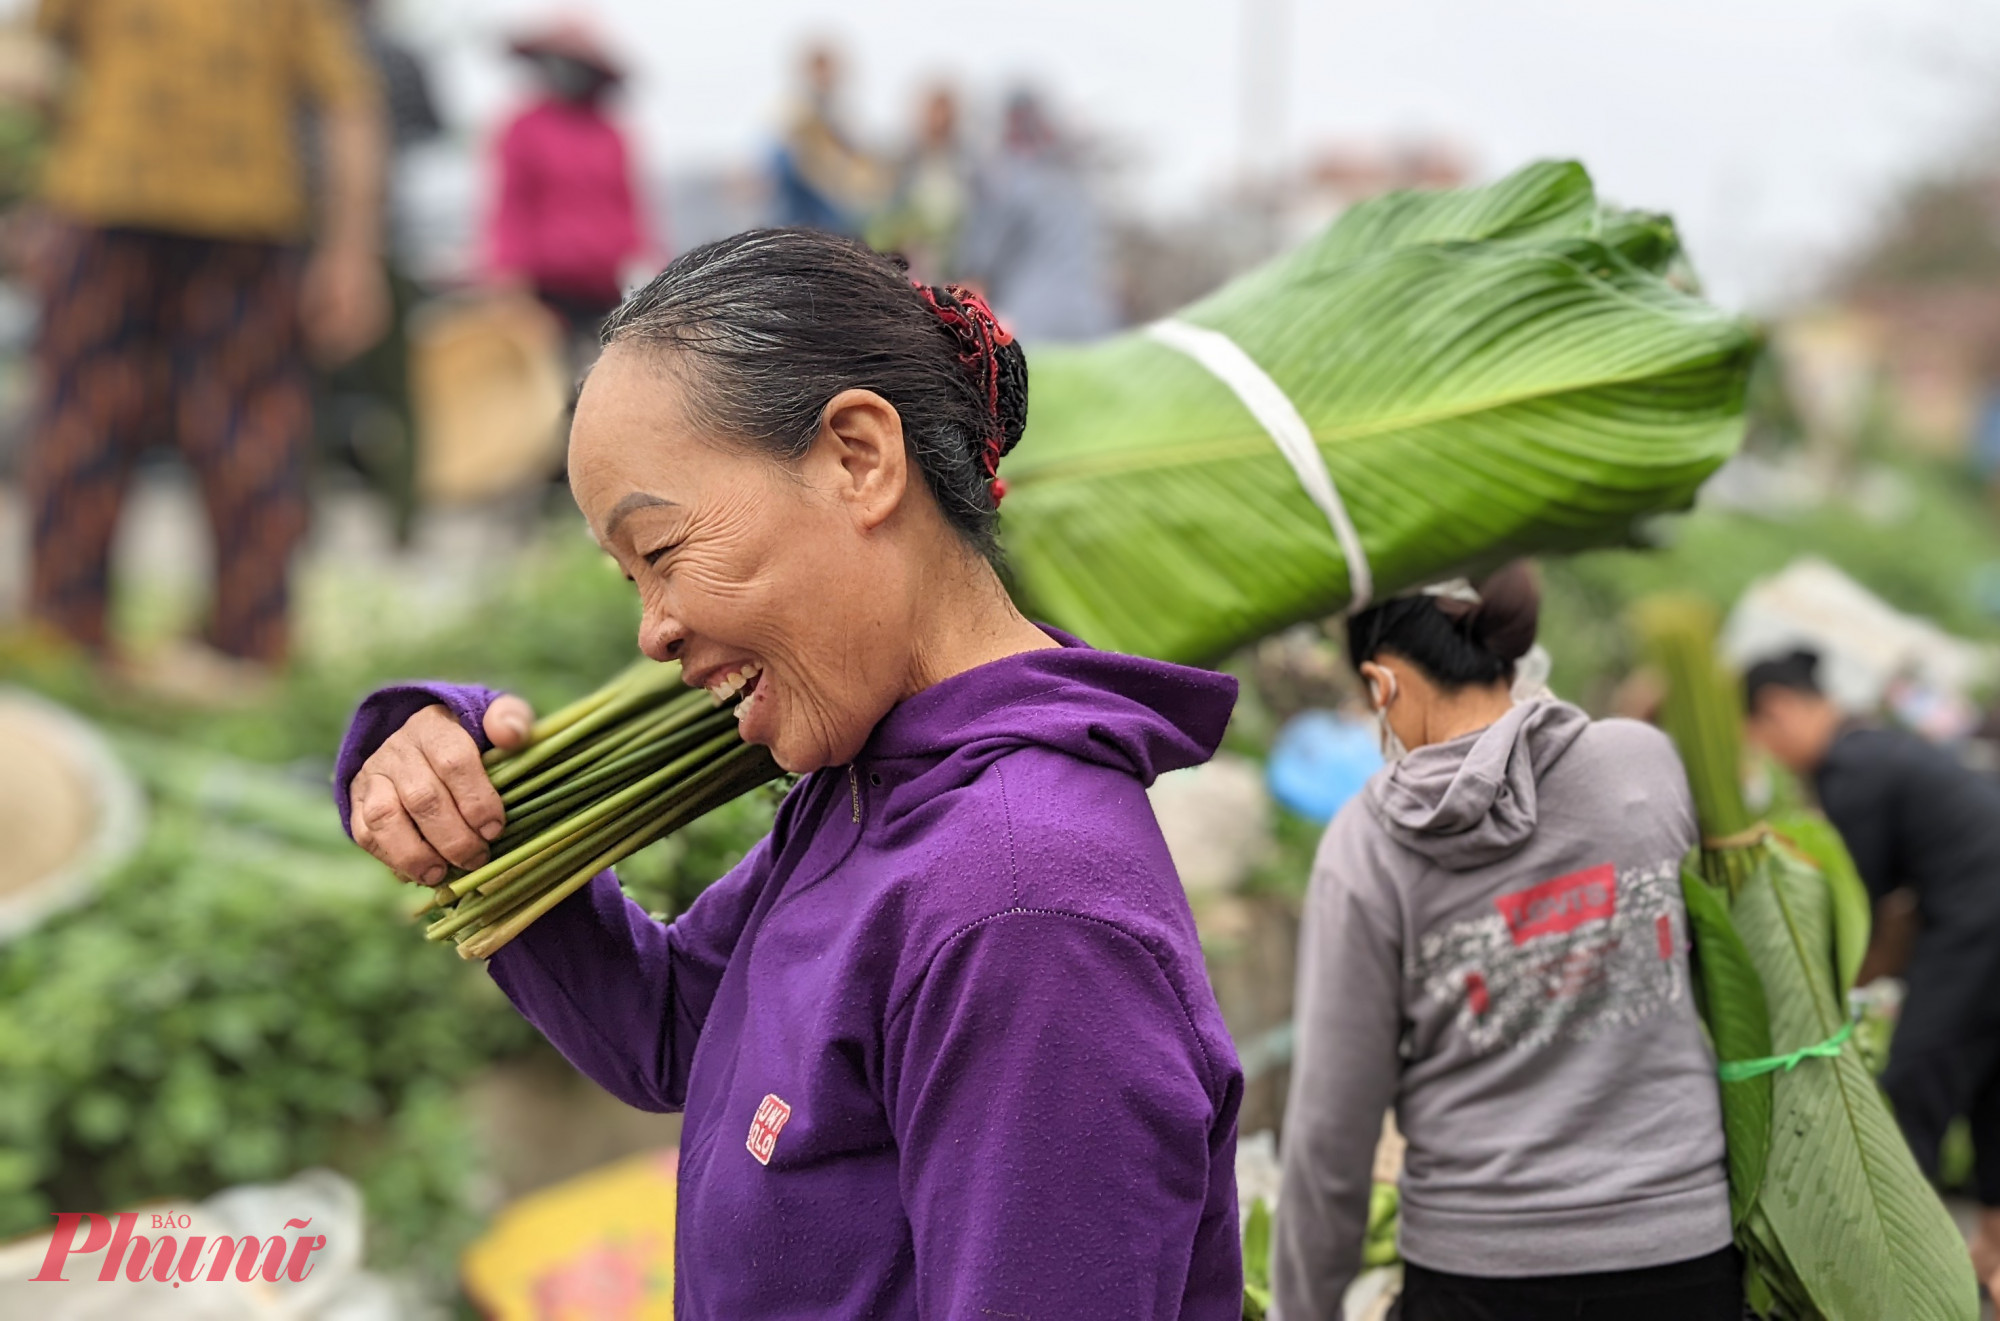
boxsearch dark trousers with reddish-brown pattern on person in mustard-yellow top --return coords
[24,226,312,663]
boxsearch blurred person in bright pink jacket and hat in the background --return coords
[486,20,654,336]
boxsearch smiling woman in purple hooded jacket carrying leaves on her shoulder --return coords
[336,230,1242,1321]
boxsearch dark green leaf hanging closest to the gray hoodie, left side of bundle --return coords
[1680,869,1772,1227]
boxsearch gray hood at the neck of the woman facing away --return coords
[1368,701,1590,871]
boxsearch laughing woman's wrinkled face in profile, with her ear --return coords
[570,344,912,773]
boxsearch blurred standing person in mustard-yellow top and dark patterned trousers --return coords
[24,0,388,673]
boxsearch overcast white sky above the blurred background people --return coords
[15,0,2000,306]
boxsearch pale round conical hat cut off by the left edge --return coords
[0,689,144,941]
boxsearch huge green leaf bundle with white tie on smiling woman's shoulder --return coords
[1002,164,1754,661]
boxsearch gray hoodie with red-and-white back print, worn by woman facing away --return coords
[1274,701,1730,1321]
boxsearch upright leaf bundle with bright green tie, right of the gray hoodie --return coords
[1640,600,1980,1321]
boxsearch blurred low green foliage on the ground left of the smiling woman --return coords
[0,528,778,1283]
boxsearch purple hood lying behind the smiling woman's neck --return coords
[858,626,1236,791]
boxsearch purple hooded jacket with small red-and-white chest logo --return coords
[336,634,1242,1321]
